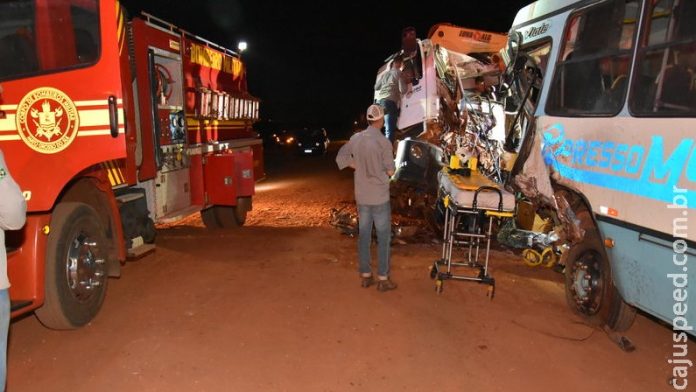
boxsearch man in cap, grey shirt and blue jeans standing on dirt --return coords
[336,105,396,291]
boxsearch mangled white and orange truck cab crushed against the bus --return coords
[376,24,506,215]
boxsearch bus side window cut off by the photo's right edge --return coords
[629,0,696,116]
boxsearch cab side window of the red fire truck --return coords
[0,0,100,80]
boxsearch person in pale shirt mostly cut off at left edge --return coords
[0,151,27,390]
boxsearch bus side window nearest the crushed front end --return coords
[546,0,640,116]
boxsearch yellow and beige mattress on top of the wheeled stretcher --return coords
[437,171,515,211]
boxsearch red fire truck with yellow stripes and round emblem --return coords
[0,0,264,329]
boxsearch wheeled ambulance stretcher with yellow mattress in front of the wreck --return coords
[430,168,515,299]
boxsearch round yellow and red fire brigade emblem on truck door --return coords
[16,87,80,154]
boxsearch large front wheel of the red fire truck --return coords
[36,202,107,329]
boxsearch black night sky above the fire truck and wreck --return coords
[122,0,531,133]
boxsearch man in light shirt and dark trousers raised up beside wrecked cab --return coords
[375,56,408,143]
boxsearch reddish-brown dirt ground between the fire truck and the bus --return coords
[8,144,696,392]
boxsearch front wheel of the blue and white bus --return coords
[565,229,635,331]
